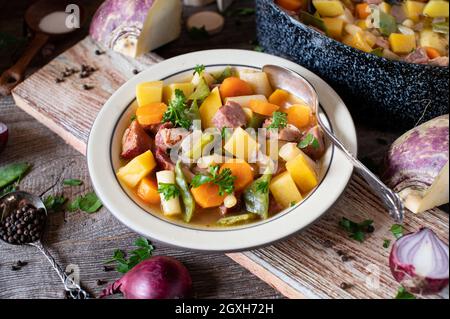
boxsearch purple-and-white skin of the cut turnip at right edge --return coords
[383,114,449,212]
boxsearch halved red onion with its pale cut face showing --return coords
[389,228,449,295]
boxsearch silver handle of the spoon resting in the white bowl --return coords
[322,125,404,223]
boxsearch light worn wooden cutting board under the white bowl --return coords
[13,38,449,298]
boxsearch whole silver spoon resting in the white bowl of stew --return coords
[263,65,404,223]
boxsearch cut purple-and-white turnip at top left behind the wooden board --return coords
[90,0,182,57]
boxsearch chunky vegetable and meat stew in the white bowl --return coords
[117,66,326,227]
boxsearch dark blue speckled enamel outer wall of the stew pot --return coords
[256,0,449,127]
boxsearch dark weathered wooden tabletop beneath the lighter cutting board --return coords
[0,0,446,298]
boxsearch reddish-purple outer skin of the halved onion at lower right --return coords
[389,228,449,295]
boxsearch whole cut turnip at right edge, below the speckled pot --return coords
[383,114,449,213]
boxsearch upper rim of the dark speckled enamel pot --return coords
[264,0,449,71]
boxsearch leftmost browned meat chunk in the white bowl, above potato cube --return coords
[121,121,153,159]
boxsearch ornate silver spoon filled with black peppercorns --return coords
[0,191,89,299]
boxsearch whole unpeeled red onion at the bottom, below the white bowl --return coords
[100,256,192,299]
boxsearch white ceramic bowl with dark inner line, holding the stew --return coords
[87,50,357,252]
